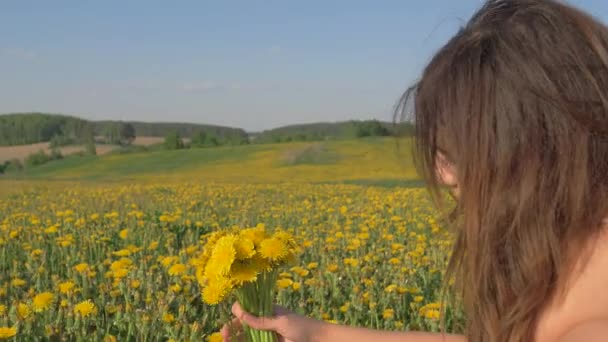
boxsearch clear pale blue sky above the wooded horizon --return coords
[0,0,608,130]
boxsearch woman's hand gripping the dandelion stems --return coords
[222,303,324,342]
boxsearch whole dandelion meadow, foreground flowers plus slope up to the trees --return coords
[0,139,463,341]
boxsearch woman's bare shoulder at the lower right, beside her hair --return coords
[536,220,608,342]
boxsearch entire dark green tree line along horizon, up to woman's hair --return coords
[0,113,414,147]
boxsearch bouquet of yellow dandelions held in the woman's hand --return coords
[196,224,296,342]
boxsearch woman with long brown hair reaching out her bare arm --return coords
[224,0,608,342]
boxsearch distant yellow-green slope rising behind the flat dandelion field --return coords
[5,138,417,184]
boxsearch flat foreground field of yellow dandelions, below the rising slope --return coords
[0,183,462,341]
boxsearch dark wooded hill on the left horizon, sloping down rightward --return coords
[0,113,247,146]
